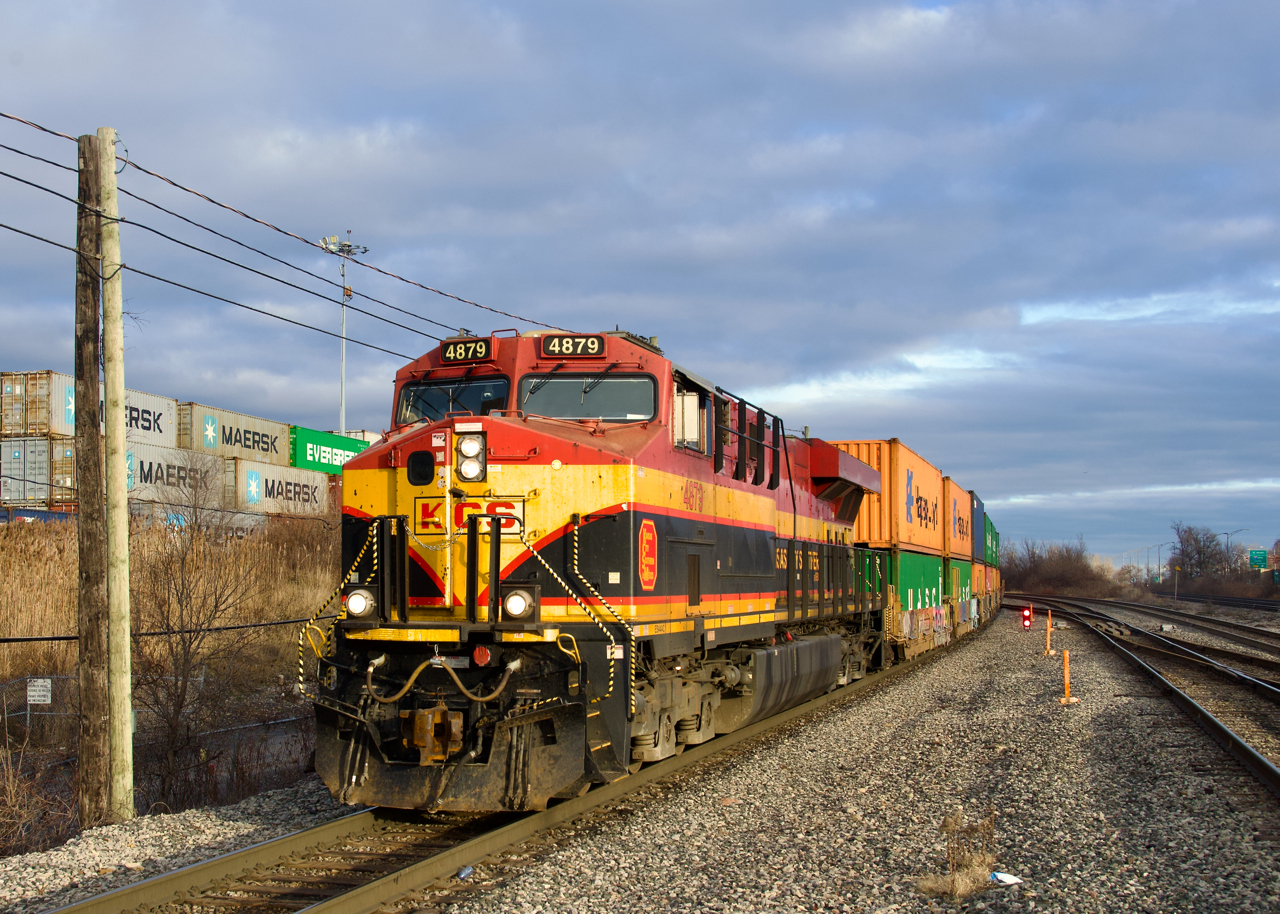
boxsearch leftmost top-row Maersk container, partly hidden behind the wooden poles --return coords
[0,371,178,448]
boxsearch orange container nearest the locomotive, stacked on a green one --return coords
[831,438,942,554]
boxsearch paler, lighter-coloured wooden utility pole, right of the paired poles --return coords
[97,127,133,822]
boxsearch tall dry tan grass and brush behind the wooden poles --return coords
[0,517,340,854]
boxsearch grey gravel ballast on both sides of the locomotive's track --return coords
[12,611,1280,914]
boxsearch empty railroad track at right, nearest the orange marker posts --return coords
[1018,595,1280,796]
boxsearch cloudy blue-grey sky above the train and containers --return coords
[0,0,1280,561]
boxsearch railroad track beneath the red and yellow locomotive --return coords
[49,622,968,914]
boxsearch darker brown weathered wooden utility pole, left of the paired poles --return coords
[76,134,110,828]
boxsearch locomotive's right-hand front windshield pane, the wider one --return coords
[518,369,657,422]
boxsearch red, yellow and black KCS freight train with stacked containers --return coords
[312,332,1000,812]
